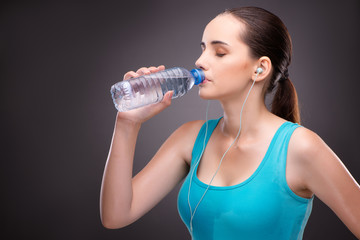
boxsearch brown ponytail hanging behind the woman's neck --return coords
[271,78,300,124]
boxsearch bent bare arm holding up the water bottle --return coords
[100,65,204,228]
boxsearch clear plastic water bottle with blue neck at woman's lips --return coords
[110,67,205,112]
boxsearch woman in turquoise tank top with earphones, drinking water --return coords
[101,7,360,240]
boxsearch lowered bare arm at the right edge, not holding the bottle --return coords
[292,128,360,239]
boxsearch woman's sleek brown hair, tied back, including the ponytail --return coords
[221,7,300,124]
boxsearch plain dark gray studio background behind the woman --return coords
[0,0,360,239]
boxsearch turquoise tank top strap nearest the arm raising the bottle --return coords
[191,117,222,167]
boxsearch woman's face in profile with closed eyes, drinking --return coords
[196,14,257,100]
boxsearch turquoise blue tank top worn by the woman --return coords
[178,118,313,240]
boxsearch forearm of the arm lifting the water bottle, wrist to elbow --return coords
[100,119,141,228]
